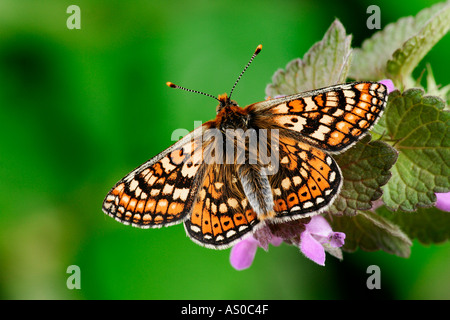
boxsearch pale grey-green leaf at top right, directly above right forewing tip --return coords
[349,2,449,81]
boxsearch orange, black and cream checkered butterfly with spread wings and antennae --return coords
[103,45,387,249]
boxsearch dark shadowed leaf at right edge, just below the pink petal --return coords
[377,206,450,244]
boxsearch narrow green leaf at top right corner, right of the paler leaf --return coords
[386,5,450,86]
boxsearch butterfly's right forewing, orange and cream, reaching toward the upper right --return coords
[249,82,387,153]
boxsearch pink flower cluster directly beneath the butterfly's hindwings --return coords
[230,216,345,270]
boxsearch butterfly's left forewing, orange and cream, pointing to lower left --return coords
[103,127,207,228]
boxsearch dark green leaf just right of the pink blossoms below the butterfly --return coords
[331,211,412,258]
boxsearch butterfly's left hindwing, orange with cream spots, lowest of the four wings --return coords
[184,165,259,249]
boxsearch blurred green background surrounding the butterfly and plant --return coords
[0,0,450,299]
